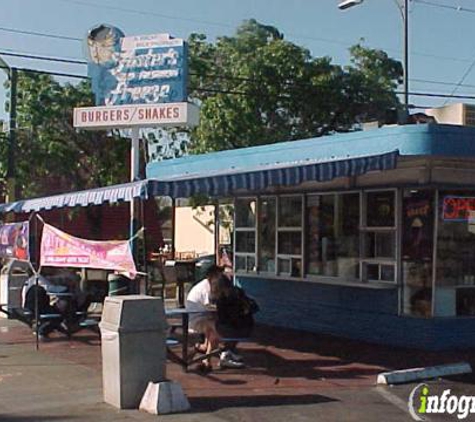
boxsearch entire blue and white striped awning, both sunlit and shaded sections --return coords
[0,151,399,213]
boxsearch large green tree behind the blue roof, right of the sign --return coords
[189,20,402,153]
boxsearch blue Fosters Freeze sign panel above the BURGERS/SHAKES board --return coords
[87,25,188,106]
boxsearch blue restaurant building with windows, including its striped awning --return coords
[0,124,475,350]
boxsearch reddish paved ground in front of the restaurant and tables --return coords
[0,320,475,422]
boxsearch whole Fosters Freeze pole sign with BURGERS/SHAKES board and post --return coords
[74,24,199,290]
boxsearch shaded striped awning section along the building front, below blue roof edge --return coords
[148,151,399,198]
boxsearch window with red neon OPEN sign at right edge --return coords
[434,191,475,316]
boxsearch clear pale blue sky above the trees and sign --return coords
[0,0,475,119]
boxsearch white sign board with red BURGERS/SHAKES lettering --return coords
[74,103,199,129]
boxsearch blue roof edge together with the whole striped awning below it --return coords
[0,125,475,213]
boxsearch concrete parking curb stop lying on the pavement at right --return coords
[376,362,472,385]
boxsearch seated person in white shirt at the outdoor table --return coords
[185,265,223,370]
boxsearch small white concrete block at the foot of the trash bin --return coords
[140,381,190,415]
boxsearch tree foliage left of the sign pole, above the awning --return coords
[2,73,129,197]
